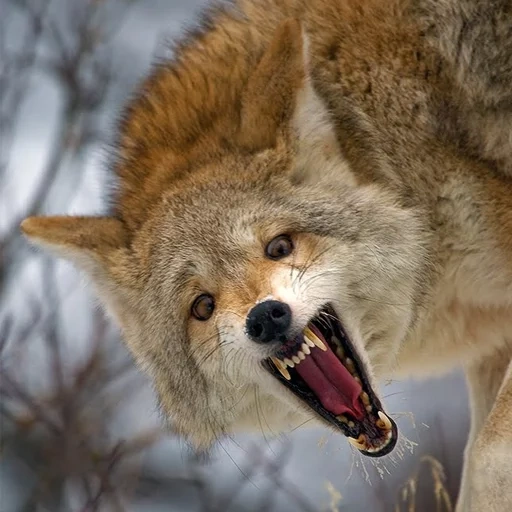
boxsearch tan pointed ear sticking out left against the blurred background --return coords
[21,217,127,277]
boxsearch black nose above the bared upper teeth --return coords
[245,300,292,343]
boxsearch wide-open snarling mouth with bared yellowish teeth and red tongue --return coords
[263,305,398,457]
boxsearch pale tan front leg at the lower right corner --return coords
[456,351,512,512]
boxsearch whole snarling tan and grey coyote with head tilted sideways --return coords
[21,0,512,512]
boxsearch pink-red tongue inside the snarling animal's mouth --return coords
[295,330,364,420]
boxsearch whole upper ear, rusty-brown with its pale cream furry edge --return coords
[240,19,342,174]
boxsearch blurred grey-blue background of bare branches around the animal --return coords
[0,0,468,512]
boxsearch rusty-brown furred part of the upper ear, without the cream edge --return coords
[240,19,305,151]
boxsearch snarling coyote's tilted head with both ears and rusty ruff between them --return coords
[23,21,425,455]
